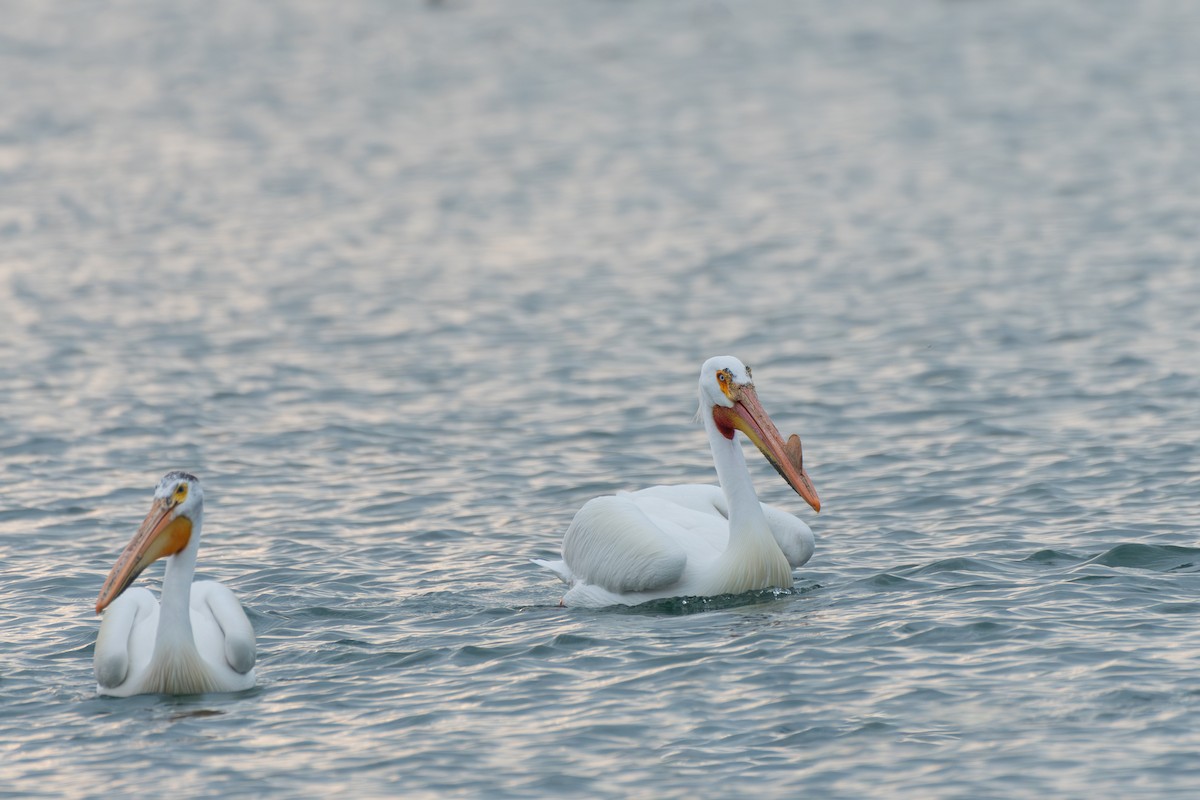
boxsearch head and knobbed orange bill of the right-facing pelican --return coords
[700,355,821,511]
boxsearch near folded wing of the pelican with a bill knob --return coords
[563,494,688,593]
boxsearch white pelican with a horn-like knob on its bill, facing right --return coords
[534,356,821,607]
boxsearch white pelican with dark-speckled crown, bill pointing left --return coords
[95,473,254,697]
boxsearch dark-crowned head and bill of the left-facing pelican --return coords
[96,471,204,614]
